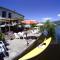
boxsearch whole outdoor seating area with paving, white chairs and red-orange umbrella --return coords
[0,20,42,60]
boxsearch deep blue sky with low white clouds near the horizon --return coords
[0,0,60,21]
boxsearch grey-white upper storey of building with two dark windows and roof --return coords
[0,7,24,19]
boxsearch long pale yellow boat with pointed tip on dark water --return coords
[19,37,51,60]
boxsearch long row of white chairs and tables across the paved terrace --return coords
[7,30,41,40]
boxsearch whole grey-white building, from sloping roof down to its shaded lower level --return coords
[0,7,24,30]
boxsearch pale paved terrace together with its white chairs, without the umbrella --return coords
[4,30,41,60]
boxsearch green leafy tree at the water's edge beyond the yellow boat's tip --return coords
[44,20,55,40]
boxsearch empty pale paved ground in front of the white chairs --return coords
[4,39,35,60]
